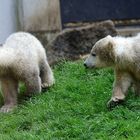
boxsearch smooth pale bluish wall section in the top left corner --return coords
[0,0,18,44]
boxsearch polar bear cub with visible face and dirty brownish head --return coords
[84,34,140,107]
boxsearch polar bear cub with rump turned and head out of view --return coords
[0,32,54,112]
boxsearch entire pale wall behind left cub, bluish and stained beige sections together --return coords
[0,0,61,44]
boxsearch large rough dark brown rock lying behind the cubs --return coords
[46,20,117,65]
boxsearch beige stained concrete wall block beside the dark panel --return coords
[19,0,61,31]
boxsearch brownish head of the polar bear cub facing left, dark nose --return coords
[84,35,115,68]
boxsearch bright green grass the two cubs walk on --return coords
[0,62,140,140]
